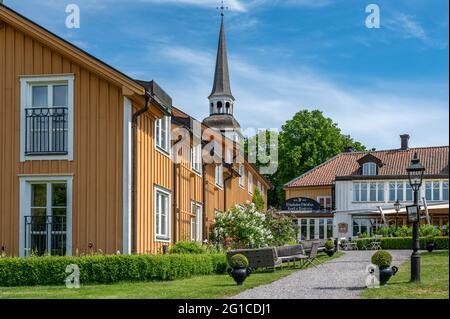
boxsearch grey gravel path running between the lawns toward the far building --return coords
[232,250,411,299]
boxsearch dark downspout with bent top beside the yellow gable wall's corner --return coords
[131,89,150,254]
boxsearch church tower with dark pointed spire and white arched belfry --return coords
[203,12,242,141]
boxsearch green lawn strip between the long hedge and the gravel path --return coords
[0,253,342,299]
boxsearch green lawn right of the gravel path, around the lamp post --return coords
[362,251,449,299]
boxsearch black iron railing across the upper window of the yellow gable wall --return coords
[25,107,68,155]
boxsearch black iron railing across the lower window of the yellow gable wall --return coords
[25,216,67,256]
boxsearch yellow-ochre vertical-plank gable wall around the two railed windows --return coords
[0,25,123,255]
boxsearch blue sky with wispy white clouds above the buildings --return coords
[4,0,449,149]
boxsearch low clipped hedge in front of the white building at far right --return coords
[356,236,449,250]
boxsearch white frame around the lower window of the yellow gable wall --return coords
[19,175,73,257]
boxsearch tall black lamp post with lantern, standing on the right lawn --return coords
[406,153,425,282]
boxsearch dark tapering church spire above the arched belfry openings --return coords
[209,14,234,101]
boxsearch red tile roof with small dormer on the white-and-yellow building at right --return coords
[284,146,449,188]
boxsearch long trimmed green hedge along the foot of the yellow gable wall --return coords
[0,254,227,287]
